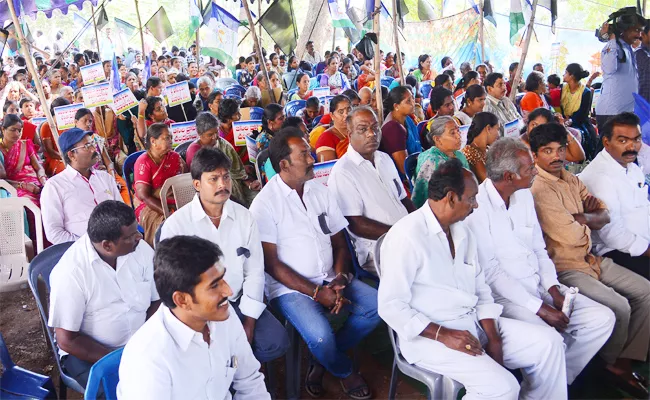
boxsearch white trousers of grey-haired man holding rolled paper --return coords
[499,286,616,385]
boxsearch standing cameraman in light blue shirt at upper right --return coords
[596,7,646,129]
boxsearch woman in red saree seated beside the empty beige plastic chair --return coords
[133,123,187,247]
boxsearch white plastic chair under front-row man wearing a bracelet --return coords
[373,235,463,400]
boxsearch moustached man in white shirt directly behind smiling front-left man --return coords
[160,148,289,362]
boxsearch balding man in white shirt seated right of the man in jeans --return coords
[327,106,415,274]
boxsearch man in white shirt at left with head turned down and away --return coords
[48,200,160,387]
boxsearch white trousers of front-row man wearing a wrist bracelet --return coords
[416,318,567,400]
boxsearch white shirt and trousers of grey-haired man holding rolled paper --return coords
[467,179,615,384]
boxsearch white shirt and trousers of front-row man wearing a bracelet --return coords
[378,203,567,399]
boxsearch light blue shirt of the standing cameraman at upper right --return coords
[596,39,639,115]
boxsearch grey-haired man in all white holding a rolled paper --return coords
[467,138,616,385]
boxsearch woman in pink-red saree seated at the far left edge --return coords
[0,114,47,207]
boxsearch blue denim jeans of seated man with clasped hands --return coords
[271,279,381,378]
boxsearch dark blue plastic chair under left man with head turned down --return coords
[27,242,84,399]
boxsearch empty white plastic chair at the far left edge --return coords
[0,197,43,292]
